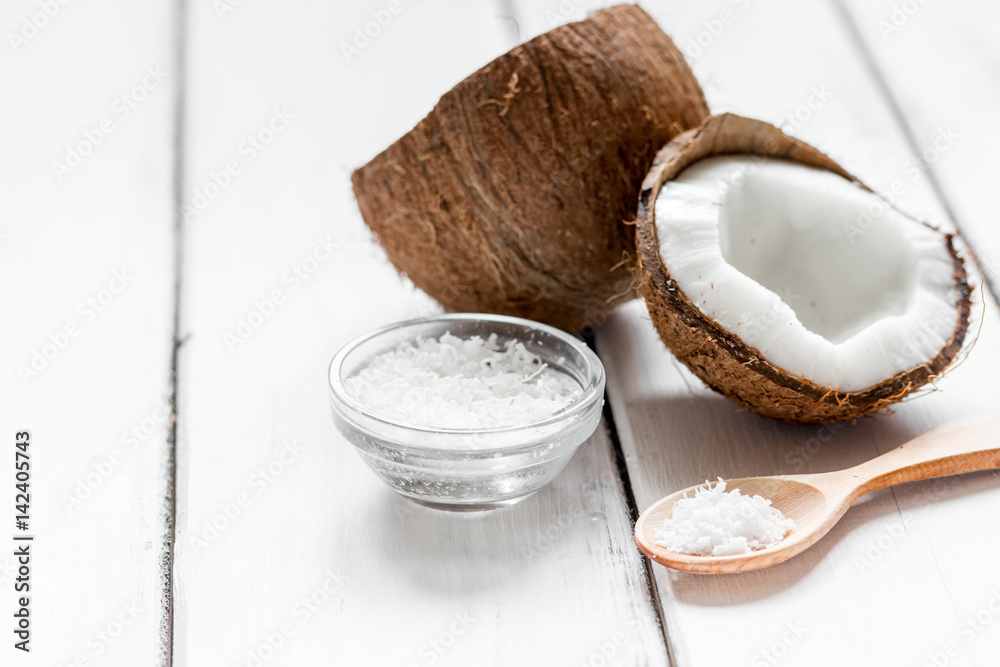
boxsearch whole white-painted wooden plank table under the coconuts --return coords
[0,0,1000,667]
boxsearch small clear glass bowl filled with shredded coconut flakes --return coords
[329,314,604,511]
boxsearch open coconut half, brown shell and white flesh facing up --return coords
[636,114,971,423]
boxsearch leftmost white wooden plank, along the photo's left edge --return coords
[0,0,174,666]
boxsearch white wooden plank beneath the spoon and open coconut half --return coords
[520,0,1000,667]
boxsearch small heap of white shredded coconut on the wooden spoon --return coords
[656,477,795,556]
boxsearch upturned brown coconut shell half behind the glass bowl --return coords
[353,5,709,330]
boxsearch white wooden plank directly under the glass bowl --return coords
[175,0,667,666]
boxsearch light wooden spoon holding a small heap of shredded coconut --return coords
[635,415,1000,574]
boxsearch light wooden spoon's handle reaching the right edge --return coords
[844,414,1000,497]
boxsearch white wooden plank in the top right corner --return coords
[843,0,1000,286]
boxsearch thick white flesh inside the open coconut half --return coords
[656,156,960,392]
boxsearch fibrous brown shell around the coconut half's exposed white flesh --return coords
[636,114,971,424]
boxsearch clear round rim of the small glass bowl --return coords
[327,313,605,454]
